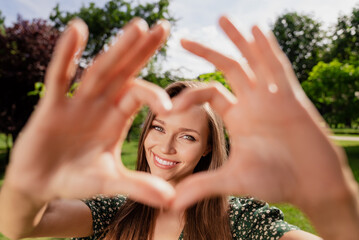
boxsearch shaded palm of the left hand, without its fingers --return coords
[16,99,125,197]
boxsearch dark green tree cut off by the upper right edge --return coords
[330,7,359,61]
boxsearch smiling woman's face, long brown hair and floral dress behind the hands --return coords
[76,81,297,239]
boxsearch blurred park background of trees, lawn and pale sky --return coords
[0,0,359,240]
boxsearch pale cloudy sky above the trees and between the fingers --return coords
[0,0,359,78]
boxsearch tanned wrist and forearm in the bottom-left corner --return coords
[0,179,46,239]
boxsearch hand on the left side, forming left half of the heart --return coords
[4,19,174,206]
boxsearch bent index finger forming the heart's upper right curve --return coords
[173,82,237,123]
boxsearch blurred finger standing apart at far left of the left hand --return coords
[45,19,88,99]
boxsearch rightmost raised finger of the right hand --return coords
[252,26,290,92]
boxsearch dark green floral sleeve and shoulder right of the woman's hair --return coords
[229,197,298,239]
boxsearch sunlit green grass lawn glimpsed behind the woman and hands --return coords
[0,136,359,240]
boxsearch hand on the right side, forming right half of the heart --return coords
[173,17,354,223]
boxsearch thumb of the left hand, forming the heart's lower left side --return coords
[63,152,175,207]
